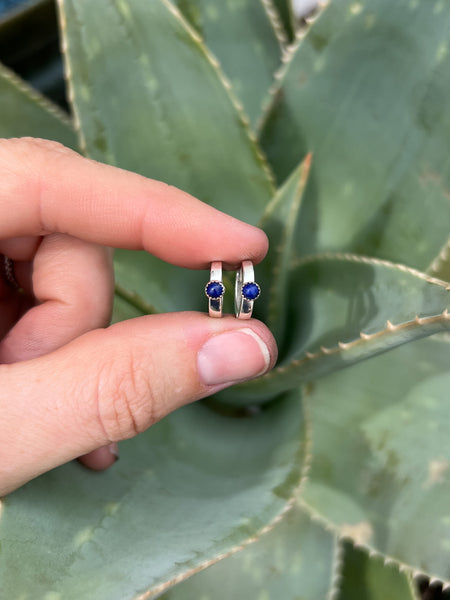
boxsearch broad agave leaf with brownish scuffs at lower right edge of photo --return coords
[302,336,450,581]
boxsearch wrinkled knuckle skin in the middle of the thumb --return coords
[96,349,155,441]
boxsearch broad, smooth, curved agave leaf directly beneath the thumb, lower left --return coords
[0,391,305,600]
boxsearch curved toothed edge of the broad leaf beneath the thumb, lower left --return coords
[133,392,312,600]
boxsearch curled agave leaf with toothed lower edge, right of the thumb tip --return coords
[216,254,450,403]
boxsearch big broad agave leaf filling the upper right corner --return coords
[262,0,450,270]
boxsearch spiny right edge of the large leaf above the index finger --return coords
[162,0,275,195]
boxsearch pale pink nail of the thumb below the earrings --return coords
[197,328,270,385]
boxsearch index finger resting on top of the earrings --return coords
[0,138,268,269]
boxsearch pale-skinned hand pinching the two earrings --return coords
[0,138,277,496]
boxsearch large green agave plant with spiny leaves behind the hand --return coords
[0,0,450,600]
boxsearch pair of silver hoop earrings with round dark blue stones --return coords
[205,260,261,319]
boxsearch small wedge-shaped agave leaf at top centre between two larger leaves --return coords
[176,0,281,124]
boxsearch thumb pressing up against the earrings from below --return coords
[0,313,277,496]
